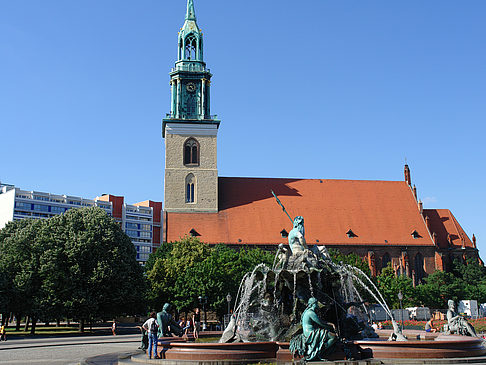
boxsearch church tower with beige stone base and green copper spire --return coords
[162,0,220,212]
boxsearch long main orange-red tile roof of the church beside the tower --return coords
[166,177,433,246]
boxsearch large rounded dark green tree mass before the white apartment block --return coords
[0,208,146,332]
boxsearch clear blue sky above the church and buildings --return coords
[0,0,486,258]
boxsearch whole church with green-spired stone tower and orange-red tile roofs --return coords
[162,0,480,283]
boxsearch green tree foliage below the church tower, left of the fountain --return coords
[147,236,273,315]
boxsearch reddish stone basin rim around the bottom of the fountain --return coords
[160,331,486,363]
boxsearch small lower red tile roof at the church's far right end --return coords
[424,209,474,248]
